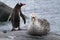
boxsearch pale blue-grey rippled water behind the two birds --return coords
[0,0,60,34]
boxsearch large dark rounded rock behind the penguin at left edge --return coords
[0,2,12,22]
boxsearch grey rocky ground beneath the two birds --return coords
[0,30,60,40]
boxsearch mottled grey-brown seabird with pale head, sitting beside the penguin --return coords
[27,14,50,36]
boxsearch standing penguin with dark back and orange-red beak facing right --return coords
[8,3,26,31]
